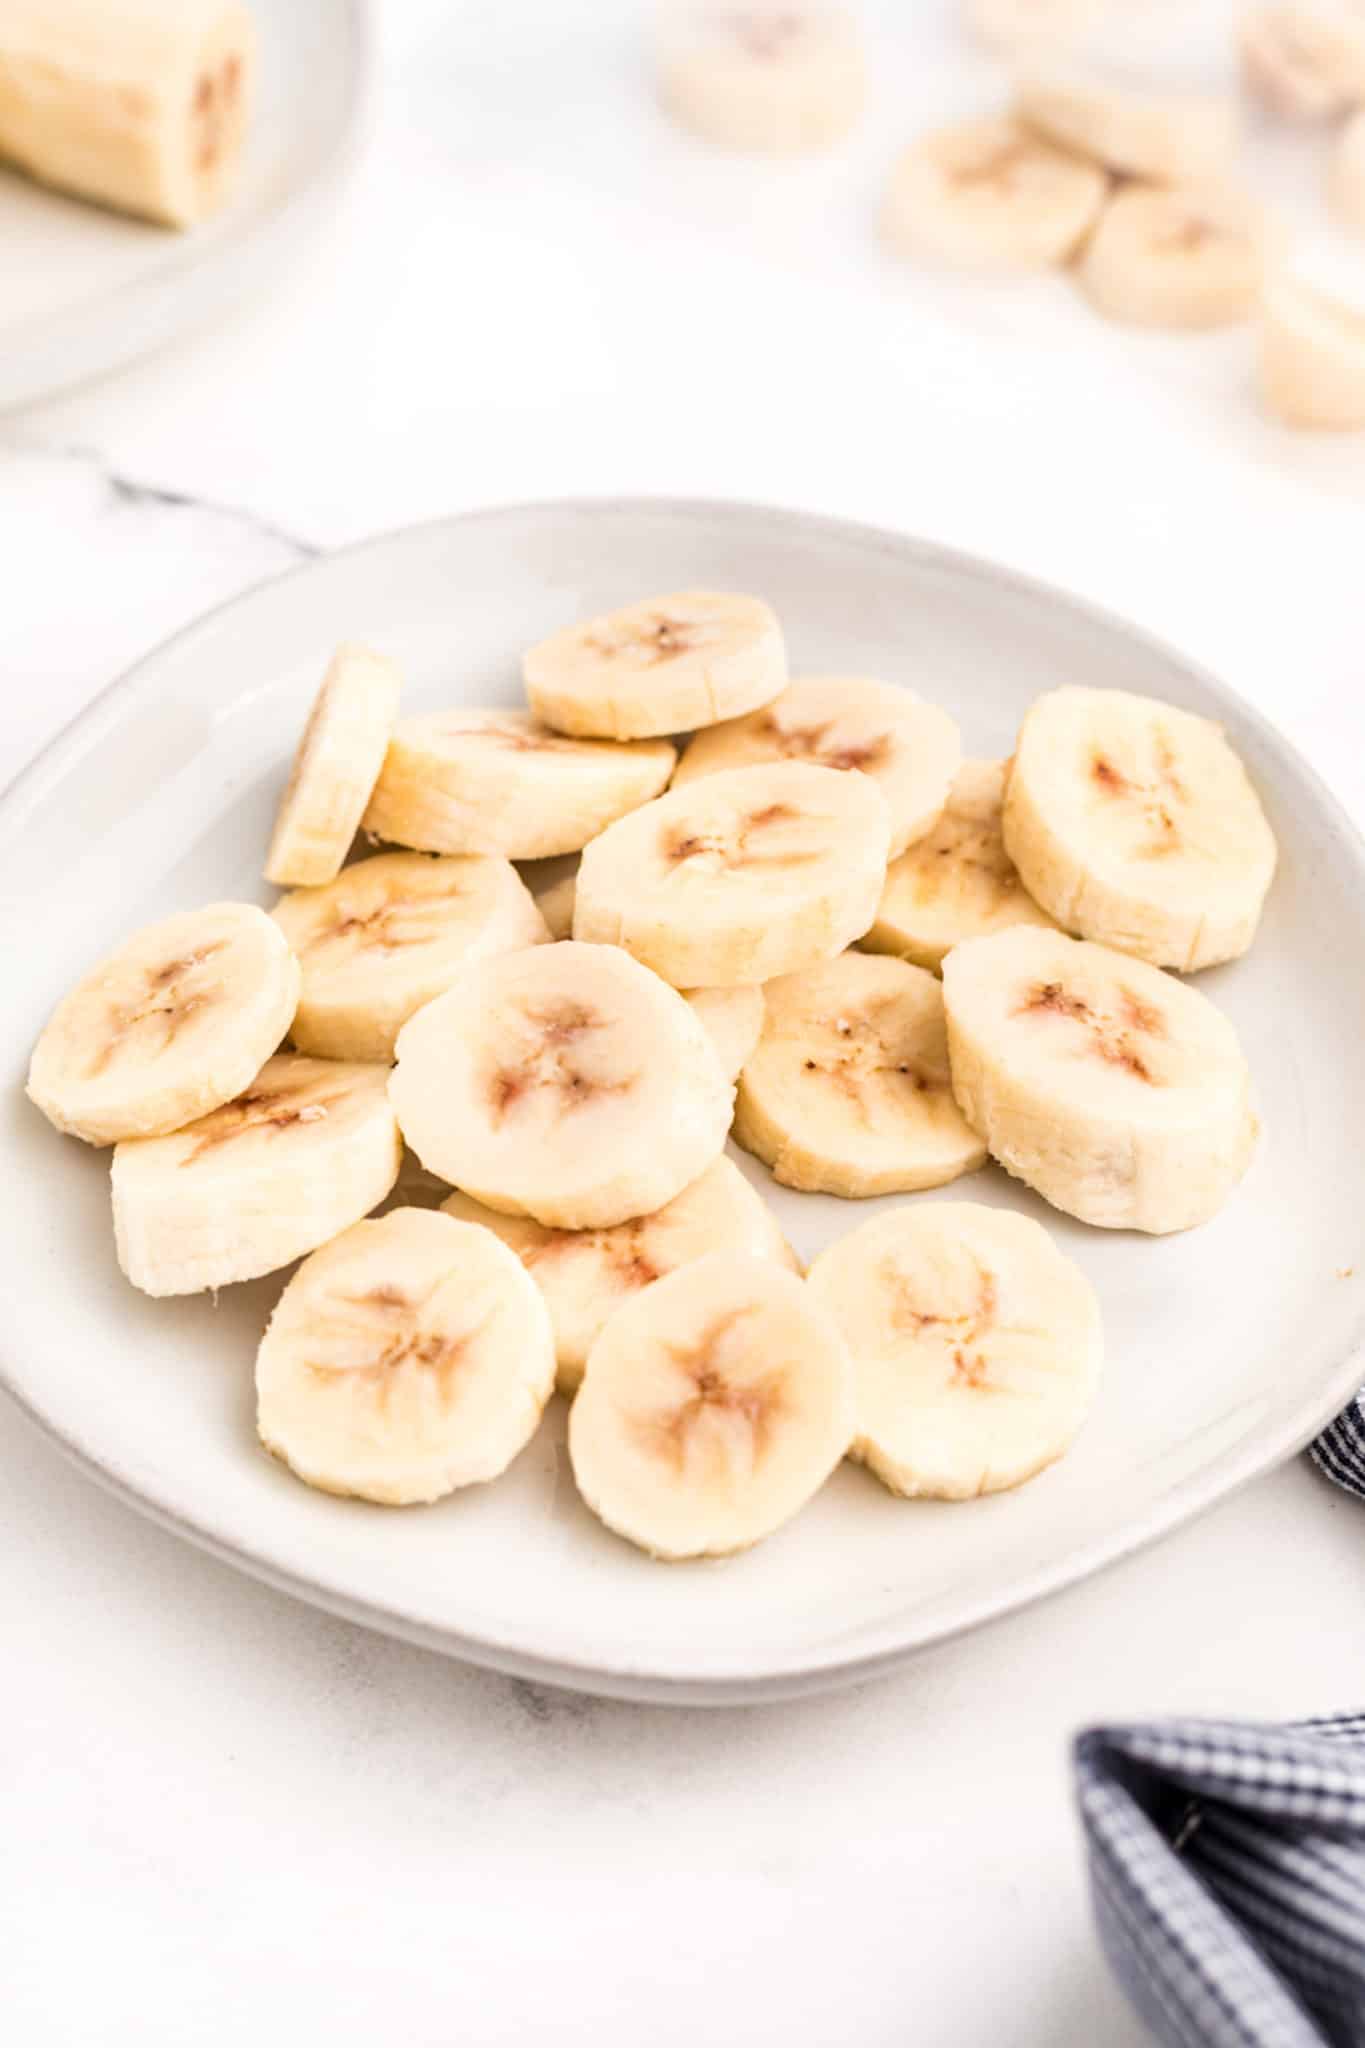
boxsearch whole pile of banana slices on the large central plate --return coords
[29,590,1275,1559]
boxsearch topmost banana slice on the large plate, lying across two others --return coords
[522,590,786,745]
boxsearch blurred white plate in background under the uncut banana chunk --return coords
[0,0,368,406]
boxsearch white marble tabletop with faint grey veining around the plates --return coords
[0,0,1365,2048]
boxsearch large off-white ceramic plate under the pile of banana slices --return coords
[0,502,1365,1700]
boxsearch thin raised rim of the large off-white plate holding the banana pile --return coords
[0,499,1365,1706]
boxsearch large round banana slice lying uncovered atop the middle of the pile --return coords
[391,942,733,1231]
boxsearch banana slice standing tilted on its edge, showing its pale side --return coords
[266,647,399,889]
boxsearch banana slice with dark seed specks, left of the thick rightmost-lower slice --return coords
[735,952,986,1196]
